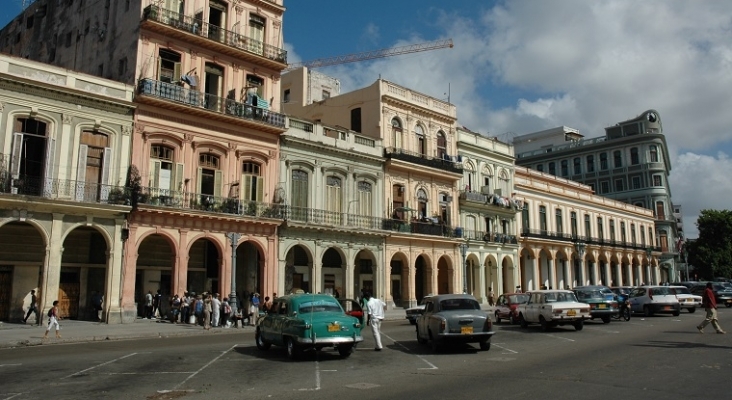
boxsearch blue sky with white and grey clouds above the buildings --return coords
[0,0,732,238]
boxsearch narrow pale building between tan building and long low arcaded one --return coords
[457,127,520,304]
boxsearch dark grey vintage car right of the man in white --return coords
[417,294,494,351]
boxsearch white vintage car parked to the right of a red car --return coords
[517,290,591,331]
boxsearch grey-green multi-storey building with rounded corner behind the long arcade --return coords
[514,110,680,282]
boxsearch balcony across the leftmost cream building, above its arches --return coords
[0,173,129,205]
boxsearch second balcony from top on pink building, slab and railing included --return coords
[137,78,287,133]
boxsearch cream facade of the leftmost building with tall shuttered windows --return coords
[0,55,135,322]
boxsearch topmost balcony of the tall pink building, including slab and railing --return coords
[141,5,287,71]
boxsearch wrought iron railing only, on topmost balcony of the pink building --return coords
[142,5,287,64]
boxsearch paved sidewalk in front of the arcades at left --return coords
[0,308,406,348]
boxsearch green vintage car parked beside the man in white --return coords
[254,294,363,359]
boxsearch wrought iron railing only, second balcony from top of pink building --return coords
[137,78,286,129]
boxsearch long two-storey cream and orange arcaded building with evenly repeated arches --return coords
[515,166,663,291]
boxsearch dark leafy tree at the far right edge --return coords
[687,210,732,280]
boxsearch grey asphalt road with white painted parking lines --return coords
[0,308,732,400]
